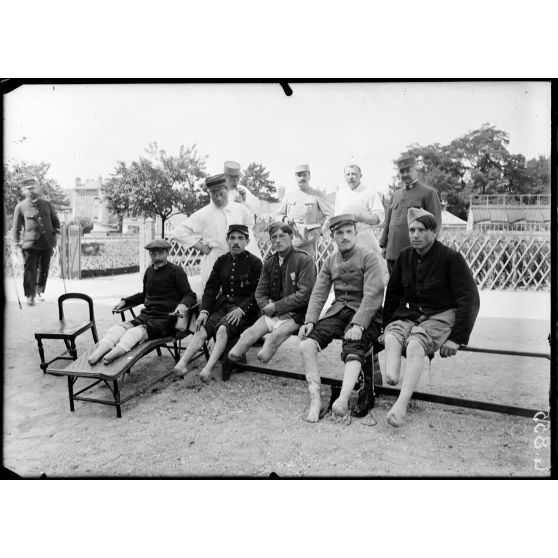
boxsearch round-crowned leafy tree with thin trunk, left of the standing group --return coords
[101,142,209,236]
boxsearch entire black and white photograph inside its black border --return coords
[3,80,554,479]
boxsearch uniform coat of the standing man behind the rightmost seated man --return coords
[379,180,442,260]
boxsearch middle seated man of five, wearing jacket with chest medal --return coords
[229,223,316,368]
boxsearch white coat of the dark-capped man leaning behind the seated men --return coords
[172,201,261,288]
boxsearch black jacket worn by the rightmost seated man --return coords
[384,240,480,345]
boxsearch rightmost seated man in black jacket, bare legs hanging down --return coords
[384,207,480,426]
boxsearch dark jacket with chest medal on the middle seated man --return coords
[256,248,316,323]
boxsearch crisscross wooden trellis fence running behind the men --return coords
[4,223,550,291]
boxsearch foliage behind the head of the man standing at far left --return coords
[4,161,70,218]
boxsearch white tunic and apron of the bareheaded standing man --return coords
[335,184,385,255]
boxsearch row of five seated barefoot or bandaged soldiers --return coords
[89,192,479,427]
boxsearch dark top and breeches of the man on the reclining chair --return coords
[122,262,197,339]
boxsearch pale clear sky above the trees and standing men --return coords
[4,81,550,198]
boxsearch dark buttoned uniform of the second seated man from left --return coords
[201,252,262,339]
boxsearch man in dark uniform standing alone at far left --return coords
[12,178,60,306]
